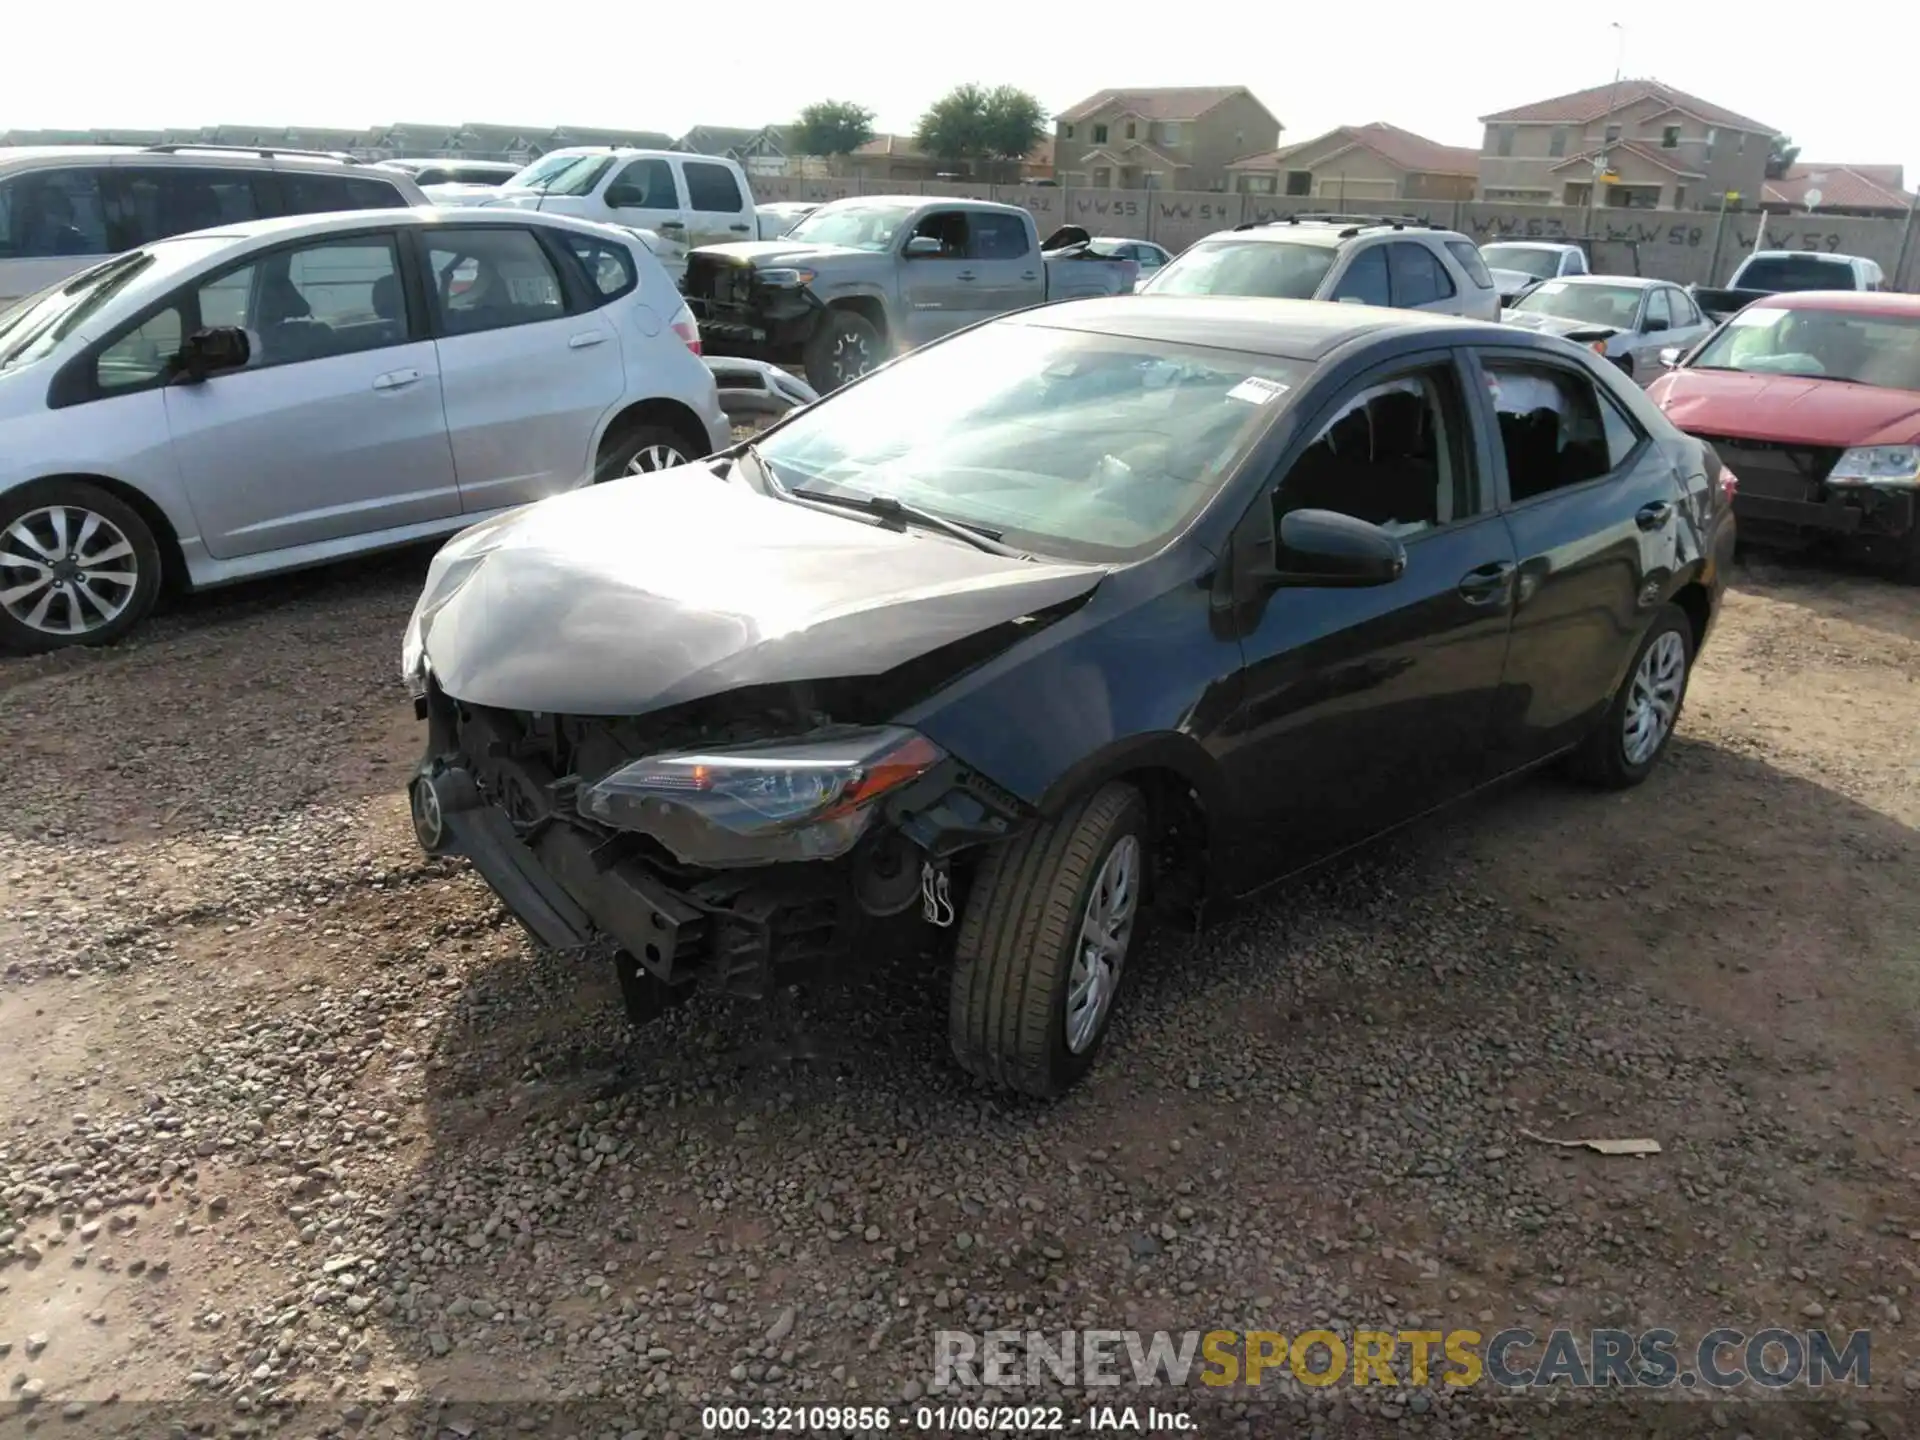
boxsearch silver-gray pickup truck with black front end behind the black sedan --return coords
[682,196,1139,394]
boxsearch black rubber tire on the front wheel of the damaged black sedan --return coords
[947,783,1152,1098]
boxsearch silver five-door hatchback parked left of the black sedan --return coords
[0,209,732,651]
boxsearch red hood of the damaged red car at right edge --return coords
[1647,369,1920,447]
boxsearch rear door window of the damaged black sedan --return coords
[1486,359,1640,503]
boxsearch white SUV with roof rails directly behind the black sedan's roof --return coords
[1140,215,1500,321]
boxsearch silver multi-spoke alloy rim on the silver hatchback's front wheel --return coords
[0,505,140,636]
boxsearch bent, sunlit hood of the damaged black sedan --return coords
[415,463,1104,714]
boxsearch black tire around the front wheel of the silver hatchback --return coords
[0,480,161,655]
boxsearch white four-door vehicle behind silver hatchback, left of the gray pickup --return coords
[426,146,758,280]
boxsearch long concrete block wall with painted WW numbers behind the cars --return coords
[753,175,1920,290]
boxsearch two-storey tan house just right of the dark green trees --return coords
[1054,84,1284,190]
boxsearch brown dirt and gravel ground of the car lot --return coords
[0,555,1920,1436]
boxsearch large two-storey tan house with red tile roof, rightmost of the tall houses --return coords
[1478,79,1780,209]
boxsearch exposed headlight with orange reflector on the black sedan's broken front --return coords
[580,726,947,866]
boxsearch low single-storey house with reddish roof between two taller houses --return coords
[1227,121,1480,209]
